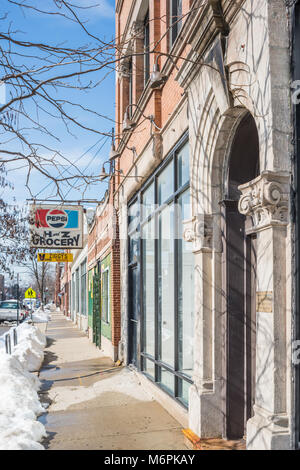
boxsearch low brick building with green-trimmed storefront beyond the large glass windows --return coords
[88,185,120,361]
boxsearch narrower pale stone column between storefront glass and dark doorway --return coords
[184,214,223,437]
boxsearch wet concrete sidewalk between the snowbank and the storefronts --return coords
[40,313,186,450]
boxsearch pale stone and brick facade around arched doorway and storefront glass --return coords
[115,0,293,449]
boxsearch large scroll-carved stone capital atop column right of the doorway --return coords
[239,171,290,232]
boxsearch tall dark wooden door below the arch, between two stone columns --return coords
[224,201,256,439]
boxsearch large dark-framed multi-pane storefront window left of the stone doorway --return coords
[128,136,194,406]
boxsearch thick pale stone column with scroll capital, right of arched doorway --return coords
[239,171,290,449]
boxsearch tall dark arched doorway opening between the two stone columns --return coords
[222,113,259,439]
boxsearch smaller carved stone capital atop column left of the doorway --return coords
[183,214,213,253]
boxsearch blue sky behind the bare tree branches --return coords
[0,0,115,207]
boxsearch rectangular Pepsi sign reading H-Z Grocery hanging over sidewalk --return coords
[30,204,83,250]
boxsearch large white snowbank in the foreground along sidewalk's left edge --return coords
[0,322,46,450]
